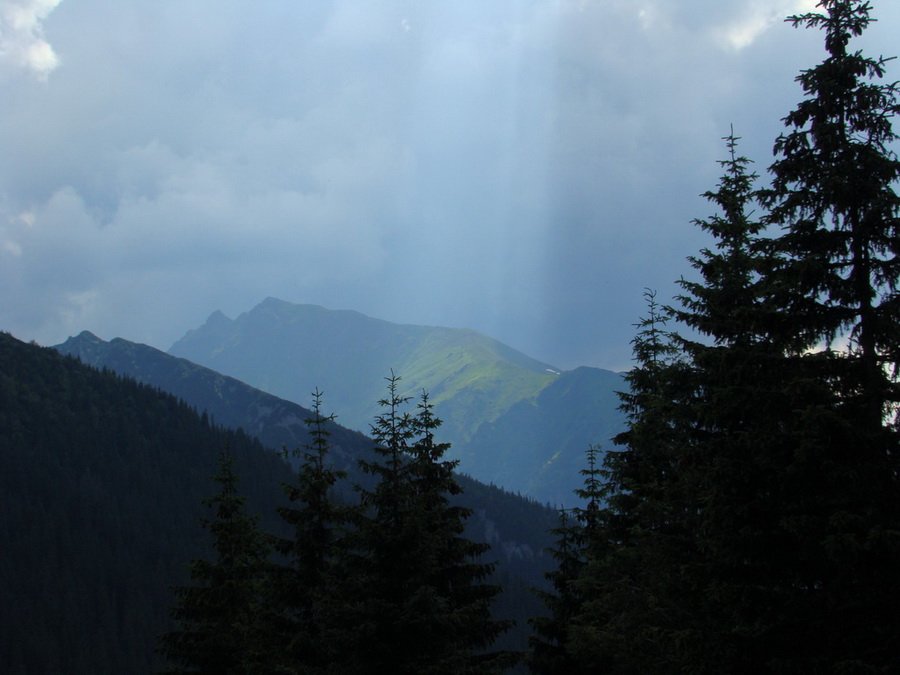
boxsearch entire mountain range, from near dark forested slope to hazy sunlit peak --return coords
[7,299,621,673]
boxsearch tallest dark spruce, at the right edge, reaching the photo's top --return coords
[767,0,900,672]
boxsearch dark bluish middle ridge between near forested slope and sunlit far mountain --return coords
[52,331,557,656]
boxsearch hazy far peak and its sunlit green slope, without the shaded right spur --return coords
[169,298,555,444]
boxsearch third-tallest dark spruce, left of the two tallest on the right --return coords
[568,291,694,673]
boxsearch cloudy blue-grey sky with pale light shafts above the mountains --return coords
[0,0,900,370]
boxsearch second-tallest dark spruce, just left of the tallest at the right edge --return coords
[675,133,816,673]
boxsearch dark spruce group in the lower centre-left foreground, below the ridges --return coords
[162,375,517,675]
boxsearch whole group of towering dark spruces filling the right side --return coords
[530,0,900,675]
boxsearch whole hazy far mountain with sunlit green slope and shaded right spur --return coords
[169,298,623,505]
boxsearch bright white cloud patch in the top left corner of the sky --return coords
[0,0,61,80]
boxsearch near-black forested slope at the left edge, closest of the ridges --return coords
[0,333,291,675]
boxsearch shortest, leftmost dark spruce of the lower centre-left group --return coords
[160,450,270,675]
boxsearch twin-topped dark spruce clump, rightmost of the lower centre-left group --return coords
[341,374,509,675]
